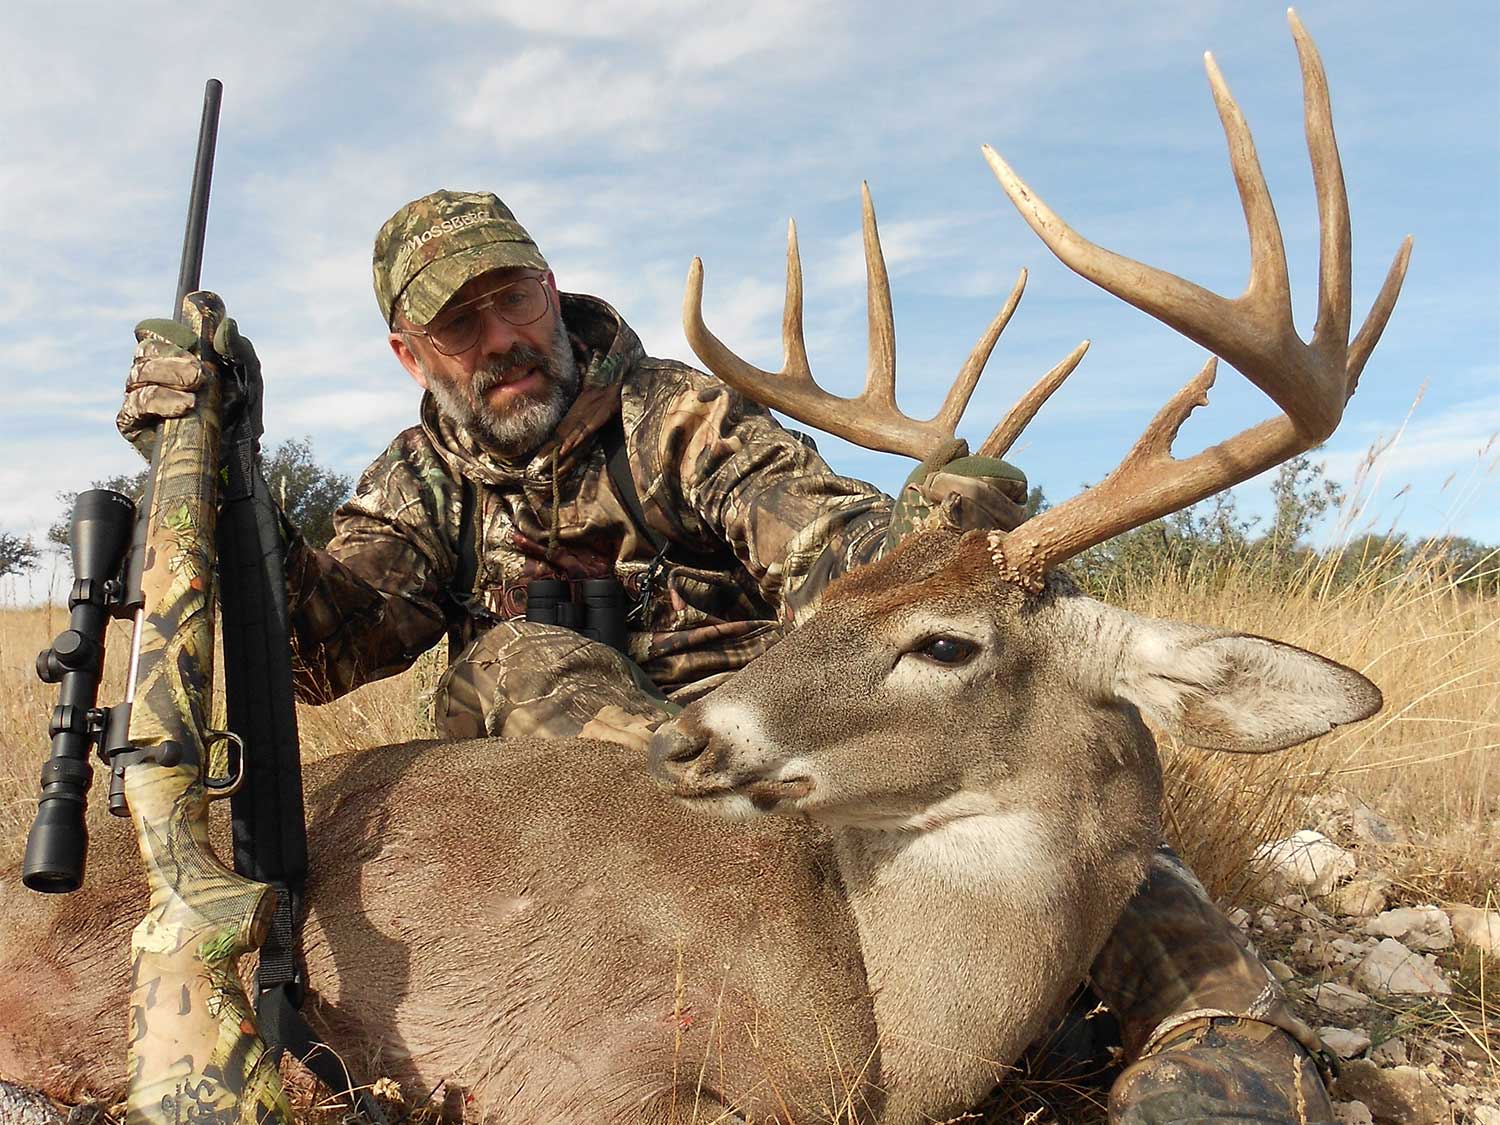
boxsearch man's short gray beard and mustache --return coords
[428,317,579,461]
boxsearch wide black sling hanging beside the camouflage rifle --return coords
[218,420,390,1124]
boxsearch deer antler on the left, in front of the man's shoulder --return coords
[683,185,1088,461]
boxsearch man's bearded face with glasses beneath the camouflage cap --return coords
[390,270,579,458]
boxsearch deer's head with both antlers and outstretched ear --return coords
[653,14,1410,828]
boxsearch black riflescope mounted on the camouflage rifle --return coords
[21,489,135,894]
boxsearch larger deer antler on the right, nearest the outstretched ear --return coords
[984,11,1412,590]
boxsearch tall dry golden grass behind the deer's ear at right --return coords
[1086,543,1500,902]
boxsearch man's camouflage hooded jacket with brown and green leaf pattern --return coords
[288,294,891,701]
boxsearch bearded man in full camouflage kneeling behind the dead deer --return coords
[119,191,1332,1125]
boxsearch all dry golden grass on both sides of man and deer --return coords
[0,543,1500,1122]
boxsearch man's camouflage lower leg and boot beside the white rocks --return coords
[1092,848,1335,1125]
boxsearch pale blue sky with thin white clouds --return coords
[0,0,1500,599]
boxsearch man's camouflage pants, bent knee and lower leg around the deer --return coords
[435,621,1320,1059]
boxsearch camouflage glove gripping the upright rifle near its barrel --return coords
[114,309,261,459]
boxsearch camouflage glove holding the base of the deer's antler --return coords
[885,444,1026,551]
